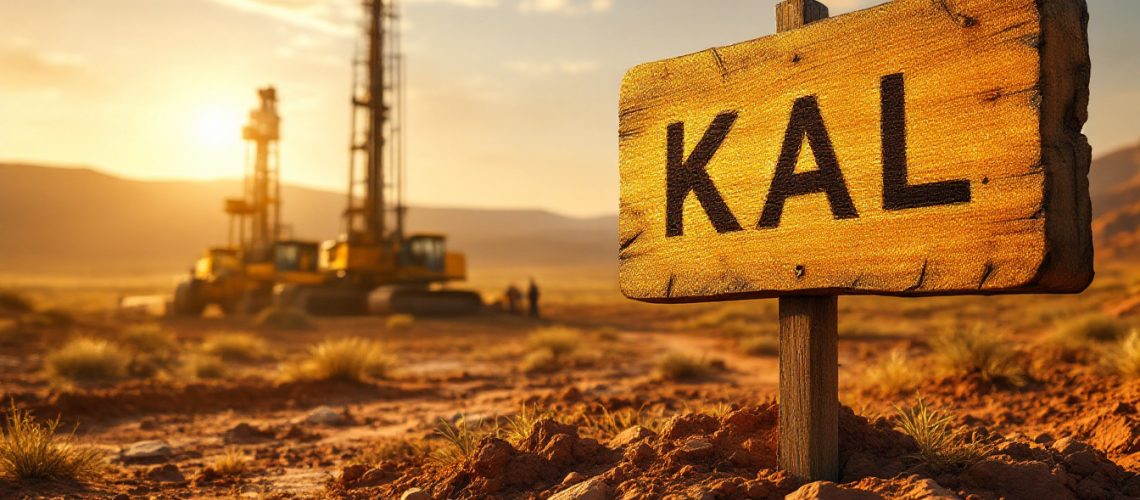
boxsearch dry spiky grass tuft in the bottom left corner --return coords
[0,407,104,482]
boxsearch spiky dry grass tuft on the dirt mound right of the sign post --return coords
[895,399,992,472]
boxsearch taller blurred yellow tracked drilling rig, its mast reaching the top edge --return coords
[285,0,483,315]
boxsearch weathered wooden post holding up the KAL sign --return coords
[776,0,839,481]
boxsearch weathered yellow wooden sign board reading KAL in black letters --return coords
[619,0,1092,302]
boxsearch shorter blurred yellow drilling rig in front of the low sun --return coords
[172,87,325,315]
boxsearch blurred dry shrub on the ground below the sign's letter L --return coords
[930,328,1025,383]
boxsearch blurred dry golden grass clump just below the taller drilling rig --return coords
[302,338,393,382]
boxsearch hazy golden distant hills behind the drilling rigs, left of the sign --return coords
[0,164,617,274]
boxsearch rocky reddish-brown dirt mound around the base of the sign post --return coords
[332,403,1140,500]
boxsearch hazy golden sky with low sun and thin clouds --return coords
[0,0,1140,215]
